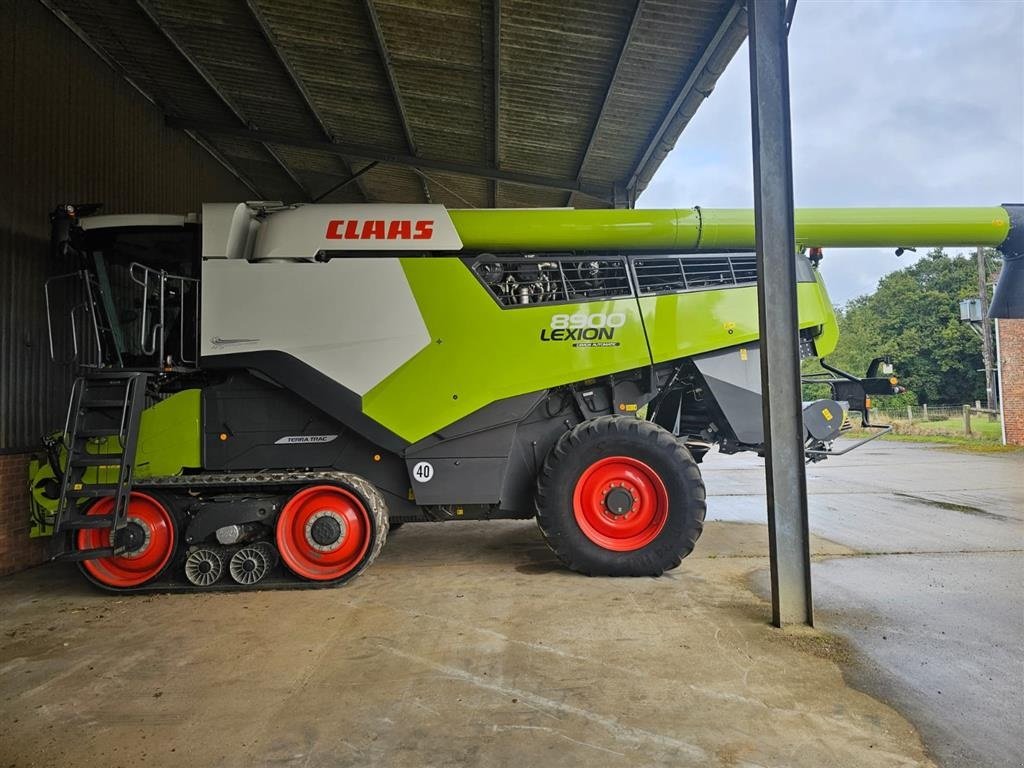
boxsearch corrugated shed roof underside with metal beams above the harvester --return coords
[50,0,745,207]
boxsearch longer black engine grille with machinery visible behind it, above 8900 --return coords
[473,255,633,307]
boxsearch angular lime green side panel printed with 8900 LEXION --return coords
[362,258,650,442]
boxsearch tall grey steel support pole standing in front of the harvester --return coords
[746,0,813,627]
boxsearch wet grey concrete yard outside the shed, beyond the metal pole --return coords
[705,441,1024,768]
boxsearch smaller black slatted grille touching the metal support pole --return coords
[633,253,758,295]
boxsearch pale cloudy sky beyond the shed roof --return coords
[637,0,1024,305]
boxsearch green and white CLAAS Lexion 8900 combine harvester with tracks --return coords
[30,203,1024,591]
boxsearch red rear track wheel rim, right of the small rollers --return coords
[276,485,373,582]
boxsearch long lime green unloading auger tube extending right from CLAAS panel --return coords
[449,206,1010,251]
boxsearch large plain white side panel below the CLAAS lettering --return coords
[200,257,430,395]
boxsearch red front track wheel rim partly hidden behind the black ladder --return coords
[76,492,175,589]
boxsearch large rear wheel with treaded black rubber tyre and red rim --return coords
[537,416,707,577]
